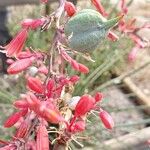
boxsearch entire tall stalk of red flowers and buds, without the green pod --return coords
[0,0,135,150]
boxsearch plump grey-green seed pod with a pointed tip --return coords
[65,9,120,52]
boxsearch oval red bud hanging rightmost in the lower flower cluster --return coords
[99,110,114,129]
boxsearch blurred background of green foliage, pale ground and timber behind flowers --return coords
[0,0,150,150]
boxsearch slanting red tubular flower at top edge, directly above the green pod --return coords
[91,0,108,17]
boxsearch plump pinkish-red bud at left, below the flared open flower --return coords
[7,58,33,74]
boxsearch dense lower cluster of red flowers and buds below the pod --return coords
[0,63,114,150]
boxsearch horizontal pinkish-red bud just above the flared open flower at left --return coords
[21,18,45,30]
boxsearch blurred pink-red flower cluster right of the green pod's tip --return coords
[118,0,150,61]
